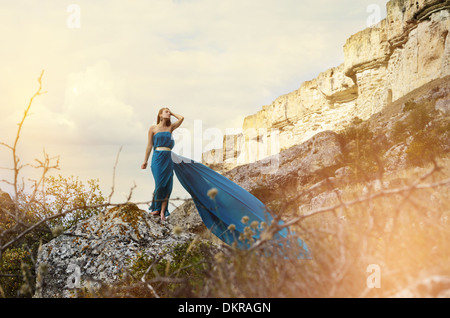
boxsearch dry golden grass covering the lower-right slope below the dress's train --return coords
[177,158,450,297]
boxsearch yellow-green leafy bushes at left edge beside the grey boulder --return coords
[0,175,105,297]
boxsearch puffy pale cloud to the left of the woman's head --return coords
[63,60,145,144]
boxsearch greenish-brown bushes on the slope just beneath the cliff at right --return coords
[340,96,450,182]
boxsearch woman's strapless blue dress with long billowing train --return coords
[149,131,310,258]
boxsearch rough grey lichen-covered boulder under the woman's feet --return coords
[36,204,194,297]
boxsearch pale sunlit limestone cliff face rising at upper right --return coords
[203,0,450,168]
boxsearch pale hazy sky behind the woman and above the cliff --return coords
[0,0,388,210]
